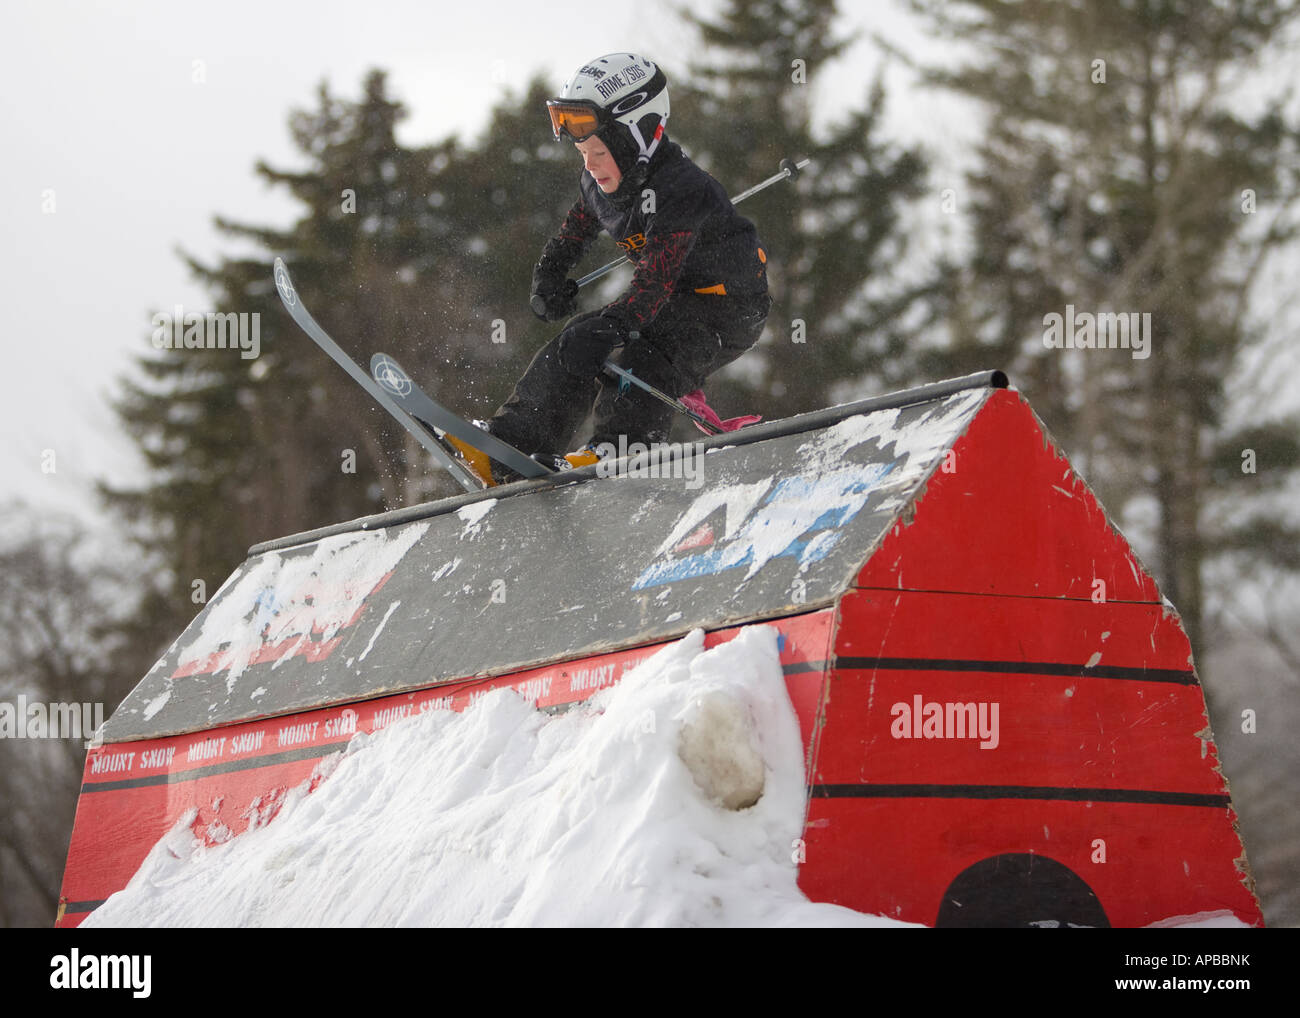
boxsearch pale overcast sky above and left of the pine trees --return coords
[0,0,972,537]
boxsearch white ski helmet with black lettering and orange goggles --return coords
[546,53,668,173]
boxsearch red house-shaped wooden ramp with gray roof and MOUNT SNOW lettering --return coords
[60,372,1262,926]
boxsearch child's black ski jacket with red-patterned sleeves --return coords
[542,138,767,329]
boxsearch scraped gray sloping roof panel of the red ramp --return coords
[104,389,989,742]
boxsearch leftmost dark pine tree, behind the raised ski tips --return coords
[104,72,460,650]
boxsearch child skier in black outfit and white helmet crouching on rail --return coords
[486,53,771,480]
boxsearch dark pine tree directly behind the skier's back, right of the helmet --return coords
[670,0,933,416]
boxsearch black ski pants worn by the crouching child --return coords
[488,294,772,454]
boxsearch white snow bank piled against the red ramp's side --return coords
[85,627,907,927]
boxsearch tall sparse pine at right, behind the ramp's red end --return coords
[913,0,1300,660]
